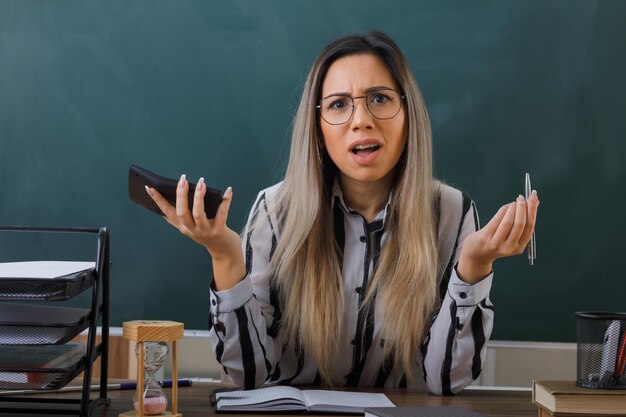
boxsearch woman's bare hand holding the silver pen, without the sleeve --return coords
[457,191,539,284]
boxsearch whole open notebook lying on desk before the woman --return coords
[215,386,395,414]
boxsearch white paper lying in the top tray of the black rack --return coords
[0,261,96,279]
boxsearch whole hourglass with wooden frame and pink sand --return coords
[120,320,184,417]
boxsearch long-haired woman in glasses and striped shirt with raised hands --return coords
[147,32,539,395]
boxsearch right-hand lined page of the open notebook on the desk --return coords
[303,390,395,413]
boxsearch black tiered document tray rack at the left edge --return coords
[0,226,111,417]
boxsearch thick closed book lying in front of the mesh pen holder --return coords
[533,381,626,417]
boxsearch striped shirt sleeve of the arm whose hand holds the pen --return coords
[422,195,493,395]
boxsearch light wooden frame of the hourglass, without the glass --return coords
[119,320,184,417]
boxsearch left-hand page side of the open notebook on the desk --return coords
[215,386,305,411]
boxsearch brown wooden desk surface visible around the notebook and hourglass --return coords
[0,383,537,417]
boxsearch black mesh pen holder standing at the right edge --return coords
[574,312,626,389]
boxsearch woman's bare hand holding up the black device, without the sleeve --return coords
[146,174,246,290]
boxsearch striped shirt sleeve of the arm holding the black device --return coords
[209,185,281,389]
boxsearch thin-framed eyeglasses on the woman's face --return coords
[317,88,406,125]
